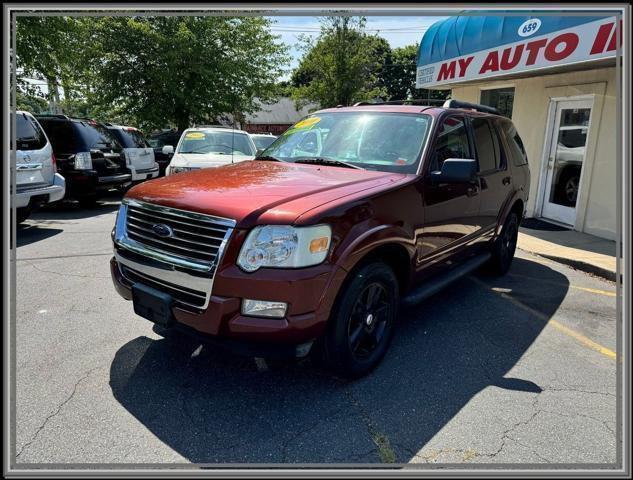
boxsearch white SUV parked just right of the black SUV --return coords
[105,123,159,183]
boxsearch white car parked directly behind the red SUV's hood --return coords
[163,126,257,175]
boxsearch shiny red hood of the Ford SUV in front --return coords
[126,160,408,228]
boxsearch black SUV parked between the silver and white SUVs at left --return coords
[36,115,132,205]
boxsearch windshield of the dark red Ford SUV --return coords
[260,111,431,173]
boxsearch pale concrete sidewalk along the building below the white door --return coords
[517,221,616,281]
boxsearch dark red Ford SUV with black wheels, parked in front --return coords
[111,100,530,377]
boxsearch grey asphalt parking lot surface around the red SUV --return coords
[15,193,617,468]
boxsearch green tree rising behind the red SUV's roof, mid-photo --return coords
[291,16,389,107]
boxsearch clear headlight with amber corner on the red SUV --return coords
[237,225,332,272]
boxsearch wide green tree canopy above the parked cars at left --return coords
[16,16,287,128]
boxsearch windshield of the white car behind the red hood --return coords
[178,130,255,155]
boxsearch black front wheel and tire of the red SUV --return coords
[323,262,400,378]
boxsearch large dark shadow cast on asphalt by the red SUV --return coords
[110,258,569,463]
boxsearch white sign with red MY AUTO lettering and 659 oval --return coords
[416,18,622,88]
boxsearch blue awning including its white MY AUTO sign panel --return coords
[416,15,621,88]
